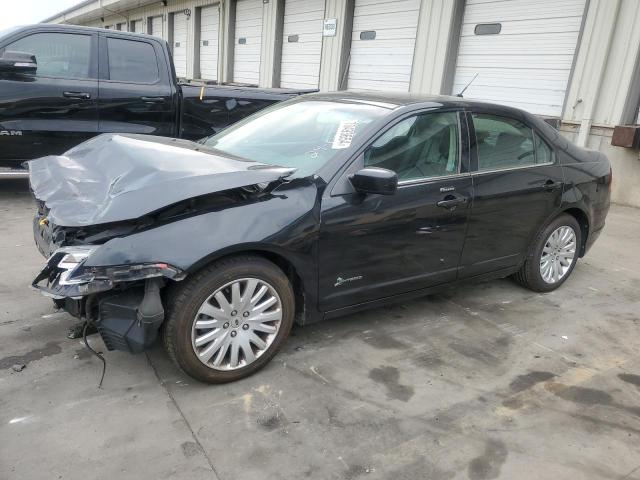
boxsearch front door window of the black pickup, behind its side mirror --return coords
[4,33,91,79]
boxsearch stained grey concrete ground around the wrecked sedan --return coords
[0,178,640,480]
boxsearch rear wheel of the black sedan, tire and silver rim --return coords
[514,214,582,292]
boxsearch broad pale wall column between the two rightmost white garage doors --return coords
[409,0,464,95]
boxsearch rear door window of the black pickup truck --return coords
[107,38,160,83]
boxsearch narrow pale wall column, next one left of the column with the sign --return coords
[259,0,284,88]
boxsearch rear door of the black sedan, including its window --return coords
[460,114,564,277]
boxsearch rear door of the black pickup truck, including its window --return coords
[98,33,178,137]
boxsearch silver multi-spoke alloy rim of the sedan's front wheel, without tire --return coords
[191,278,282,370]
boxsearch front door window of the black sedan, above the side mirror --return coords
[364,112,460,181]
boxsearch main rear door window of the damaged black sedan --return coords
[472,113,540,171]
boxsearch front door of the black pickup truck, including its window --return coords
[0,30,98,168]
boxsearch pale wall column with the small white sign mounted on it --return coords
[319,0,355,91]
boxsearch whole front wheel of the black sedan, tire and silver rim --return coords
[164,255,295,383]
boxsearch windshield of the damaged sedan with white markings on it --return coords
[204,100,389,176]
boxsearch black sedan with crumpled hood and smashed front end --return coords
[30,92,611,383]
